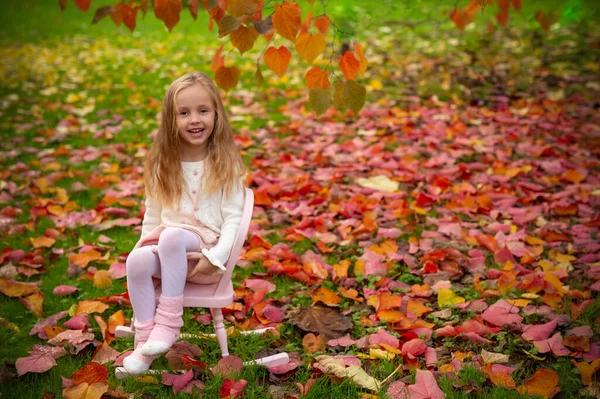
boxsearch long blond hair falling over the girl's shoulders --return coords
[144,72,247,207]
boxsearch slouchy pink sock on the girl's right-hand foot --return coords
[141,295,183,356]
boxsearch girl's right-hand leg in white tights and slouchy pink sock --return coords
[142,227,200,356]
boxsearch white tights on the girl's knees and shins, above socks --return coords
[126,227,200,322]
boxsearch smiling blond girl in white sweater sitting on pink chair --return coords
[123,73,246,375]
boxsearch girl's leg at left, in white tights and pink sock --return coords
[123,246,160,374]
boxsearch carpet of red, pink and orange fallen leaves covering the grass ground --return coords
[0,8,600,399]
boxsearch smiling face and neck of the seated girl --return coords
[175,83,216,162]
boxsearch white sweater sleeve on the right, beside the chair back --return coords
[202,184,244,270]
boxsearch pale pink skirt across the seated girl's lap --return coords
[134,224,222,284]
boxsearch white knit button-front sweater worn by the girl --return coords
[140,161,244,269]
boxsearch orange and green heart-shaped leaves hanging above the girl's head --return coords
[59,0,368,114]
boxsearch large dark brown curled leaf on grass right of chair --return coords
[292,304,353,339]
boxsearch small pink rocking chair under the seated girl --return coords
[115,188,289,378]
